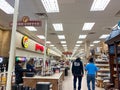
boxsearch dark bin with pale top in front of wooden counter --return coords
[36,82,52,90]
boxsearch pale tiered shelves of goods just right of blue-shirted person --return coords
[95,59,110,87]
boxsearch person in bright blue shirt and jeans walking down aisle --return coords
[85,58,99,90]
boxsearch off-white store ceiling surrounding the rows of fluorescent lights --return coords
[0,0,120,56]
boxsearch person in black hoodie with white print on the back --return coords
[72,57,84,90]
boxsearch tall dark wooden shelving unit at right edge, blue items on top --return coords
[106,30,120,90]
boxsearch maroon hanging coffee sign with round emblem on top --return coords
[10,16,42,26]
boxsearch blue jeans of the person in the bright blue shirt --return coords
[87,74,95,90]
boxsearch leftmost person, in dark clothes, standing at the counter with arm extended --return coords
[15,61,28,84]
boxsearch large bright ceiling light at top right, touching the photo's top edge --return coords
[90,0,110,11]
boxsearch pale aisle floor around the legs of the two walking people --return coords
[62,71,104,90]
